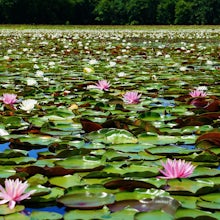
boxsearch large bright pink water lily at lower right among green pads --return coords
[160,159,195,179]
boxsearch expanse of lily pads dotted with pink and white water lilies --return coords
[0,28,220,220]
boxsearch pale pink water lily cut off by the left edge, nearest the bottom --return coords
[0,179,35,209]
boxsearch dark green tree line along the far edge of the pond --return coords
[0,0,220,25]
